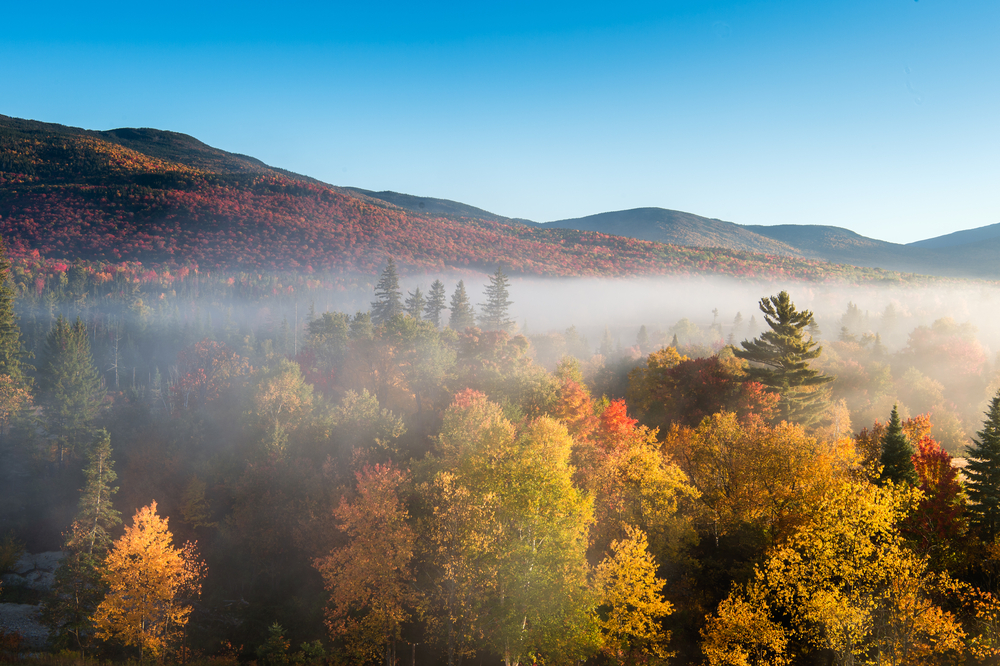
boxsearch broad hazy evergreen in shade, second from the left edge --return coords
[41,315,105,466]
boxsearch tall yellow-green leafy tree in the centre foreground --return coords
[434,391,598,666]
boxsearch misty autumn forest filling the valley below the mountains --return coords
[0,247,1000,666]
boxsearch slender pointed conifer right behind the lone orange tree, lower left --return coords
[42,430,121,652]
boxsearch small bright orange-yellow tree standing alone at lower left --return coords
[93,502,204,656]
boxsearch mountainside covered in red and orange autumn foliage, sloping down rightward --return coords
[0,116,920,282]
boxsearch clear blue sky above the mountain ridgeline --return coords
[0,0,1000,243]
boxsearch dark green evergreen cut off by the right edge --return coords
[965,392,1000,541]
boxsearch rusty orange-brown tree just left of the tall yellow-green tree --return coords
[314,465,415,666]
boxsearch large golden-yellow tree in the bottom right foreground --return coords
[704,482,964,666]
